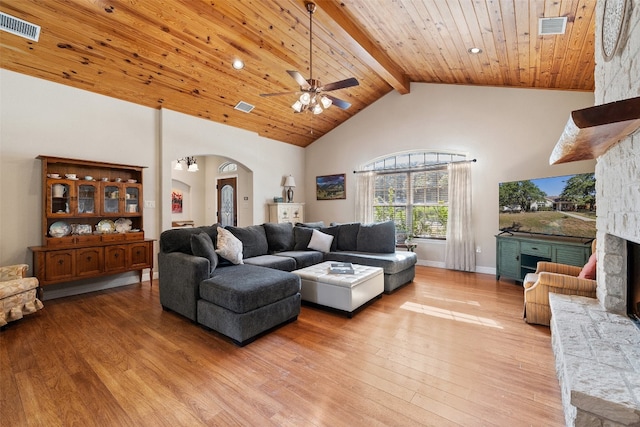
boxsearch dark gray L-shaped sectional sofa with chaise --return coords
[158,221,417,345]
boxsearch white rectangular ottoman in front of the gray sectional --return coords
[293,261,384,317]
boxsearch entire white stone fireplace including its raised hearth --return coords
[549,0,640,426]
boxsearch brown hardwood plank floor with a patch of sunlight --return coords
[0,267,564,426]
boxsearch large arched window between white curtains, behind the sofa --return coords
[361,151,467,243]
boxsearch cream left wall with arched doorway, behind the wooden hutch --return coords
[0,69,304,299]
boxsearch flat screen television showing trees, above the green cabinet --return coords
[498,173,596,239]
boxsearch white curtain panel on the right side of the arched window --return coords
[444,162,476,271]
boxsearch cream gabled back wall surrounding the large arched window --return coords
[305,83,595,273]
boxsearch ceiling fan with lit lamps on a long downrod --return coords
[260,1,359,114]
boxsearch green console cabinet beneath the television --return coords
[496,233,593,282]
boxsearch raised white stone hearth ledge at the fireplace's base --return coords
[549,294,640,427]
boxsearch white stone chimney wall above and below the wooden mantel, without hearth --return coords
[595,0,640,313]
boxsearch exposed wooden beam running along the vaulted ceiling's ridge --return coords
[318,1,410,95]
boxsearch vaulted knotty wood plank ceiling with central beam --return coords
[0,0,596,147]
